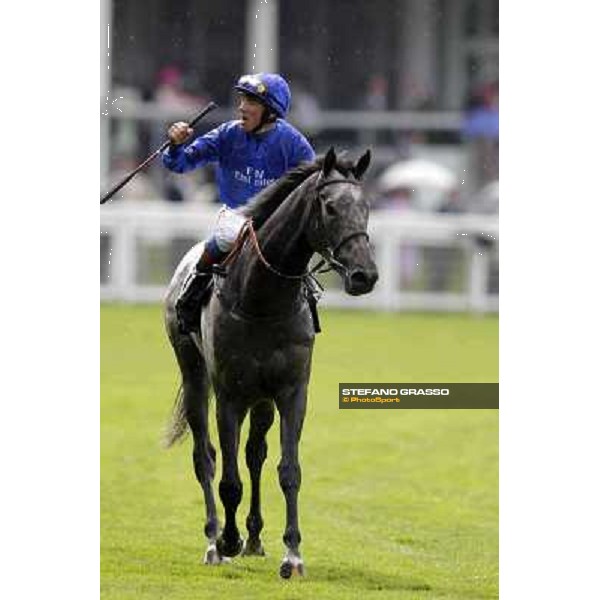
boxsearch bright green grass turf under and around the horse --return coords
[101,305,498,600]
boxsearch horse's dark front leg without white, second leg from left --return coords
[217,394,246,557]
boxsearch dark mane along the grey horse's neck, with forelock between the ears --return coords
[240,156,354,229]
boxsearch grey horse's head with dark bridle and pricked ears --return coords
[308,148,378,296]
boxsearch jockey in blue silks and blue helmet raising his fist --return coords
[162,73,315,333]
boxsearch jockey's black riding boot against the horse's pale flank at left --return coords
[175,248,218,333]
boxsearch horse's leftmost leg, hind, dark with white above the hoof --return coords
[166,334,221,564]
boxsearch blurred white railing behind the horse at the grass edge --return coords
[100,201,498,312]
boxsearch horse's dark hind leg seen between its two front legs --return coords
[243,401,275,556]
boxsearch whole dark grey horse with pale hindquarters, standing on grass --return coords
[165,148,378,578]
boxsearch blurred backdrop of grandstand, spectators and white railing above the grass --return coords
[100,0,499,313]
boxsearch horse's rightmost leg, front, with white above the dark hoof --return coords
[275,384,307,579]
